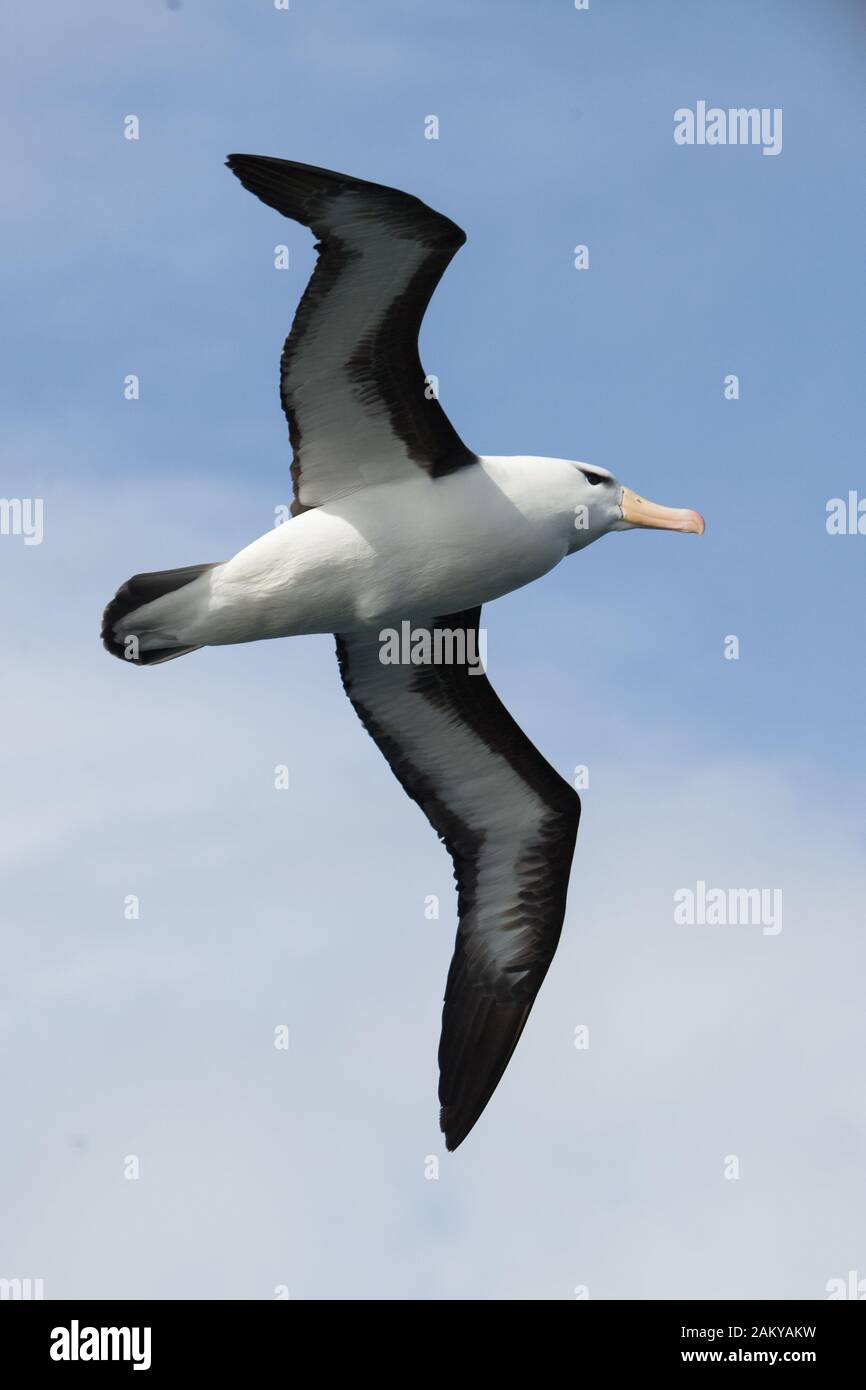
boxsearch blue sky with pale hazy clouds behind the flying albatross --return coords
[0,0,866,1298]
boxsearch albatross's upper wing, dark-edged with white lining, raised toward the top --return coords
[227,154,477,513]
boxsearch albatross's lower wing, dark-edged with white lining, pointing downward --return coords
[336,607,580,1150]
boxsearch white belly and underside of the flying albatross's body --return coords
[196,460,570,644]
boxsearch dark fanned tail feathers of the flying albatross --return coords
[101,564,215,666]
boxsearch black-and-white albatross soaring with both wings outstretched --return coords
[101,154,705,1150]
